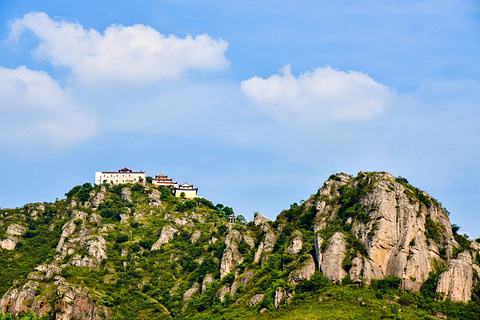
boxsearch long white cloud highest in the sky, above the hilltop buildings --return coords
[10,12,228,83]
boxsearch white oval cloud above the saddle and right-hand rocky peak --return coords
[241,66,393,124]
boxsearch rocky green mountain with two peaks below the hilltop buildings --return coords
[0,172,480,320]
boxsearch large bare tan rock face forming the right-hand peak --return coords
[314,172,458,290]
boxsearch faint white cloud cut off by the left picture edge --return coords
[0,66,96,149]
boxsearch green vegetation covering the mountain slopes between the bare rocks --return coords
[0,173,480,320]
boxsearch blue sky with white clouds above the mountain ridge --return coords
[0,0,480,238]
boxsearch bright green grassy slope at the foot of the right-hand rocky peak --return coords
[189,285,480,320]
